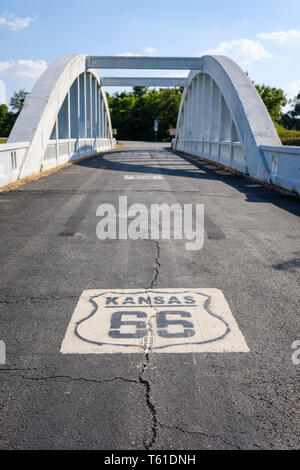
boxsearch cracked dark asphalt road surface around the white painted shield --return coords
[0,142,300,450]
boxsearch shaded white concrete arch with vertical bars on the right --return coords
[173,56,282,182]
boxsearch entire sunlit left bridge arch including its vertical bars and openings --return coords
[8,54,114,178]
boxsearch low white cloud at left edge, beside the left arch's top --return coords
[0,60,47,79]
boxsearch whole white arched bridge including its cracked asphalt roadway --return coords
[0,55,300,450]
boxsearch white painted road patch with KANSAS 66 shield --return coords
[61,289,249,354]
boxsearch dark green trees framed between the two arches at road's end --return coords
[107,87,183,142]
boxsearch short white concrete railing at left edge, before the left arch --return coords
[0,142,30,188]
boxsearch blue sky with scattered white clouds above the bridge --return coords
[0,0,300,107]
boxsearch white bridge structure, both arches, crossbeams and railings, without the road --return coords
[0,55,300,194]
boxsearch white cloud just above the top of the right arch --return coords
[201,39,273,65]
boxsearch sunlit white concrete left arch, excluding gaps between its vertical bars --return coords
[8,54,113,178]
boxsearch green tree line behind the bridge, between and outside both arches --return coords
[0,82,300,142]
